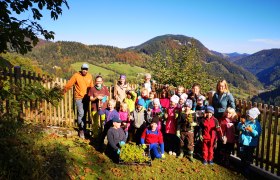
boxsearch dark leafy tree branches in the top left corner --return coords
[0,0,69,54]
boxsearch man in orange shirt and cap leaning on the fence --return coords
[63,64,93,139]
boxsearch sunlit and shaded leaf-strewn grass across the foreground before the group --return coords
[0,123,245,179]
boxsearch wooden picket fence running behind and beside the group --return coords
[0,67,280,176]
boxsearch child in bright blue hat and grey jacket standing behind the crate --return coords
[129,99,147,144]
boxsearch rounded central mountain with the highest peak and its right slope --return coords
[129,34,262,90]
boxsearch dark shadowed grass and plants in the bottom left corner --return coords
[0,121,67,179]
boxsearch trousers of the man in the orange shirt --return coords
[75,98,89,130]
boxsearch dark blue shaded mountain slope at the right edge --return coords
[234,49,280,87]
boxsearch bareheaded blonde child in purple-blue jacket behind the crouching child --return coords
[98,99,119,148]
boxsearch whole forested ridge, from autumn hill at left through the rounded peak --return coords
[1,35,262,93]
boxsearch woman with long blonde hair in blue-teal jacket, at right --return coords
[212,80,235,122]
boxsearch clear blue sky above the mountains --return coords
[19,0,280,54]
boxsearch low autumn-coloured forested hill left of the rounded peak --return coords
[26,41,150,78]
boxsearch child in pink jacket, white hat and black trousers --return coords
[164,95,180,156]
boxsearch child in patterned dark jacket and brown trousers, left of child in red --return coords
[176,103,197,162]
